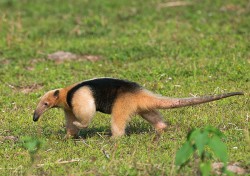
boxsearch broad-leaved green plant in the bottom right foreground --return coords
[175,126,229,176]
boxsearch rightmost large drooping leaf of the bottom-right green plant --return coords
[208,136,228,163]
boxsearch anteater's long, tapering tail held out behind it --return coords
[155,92,244,109]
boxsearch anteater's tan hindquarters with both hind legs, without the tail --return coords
[111,90,167,137]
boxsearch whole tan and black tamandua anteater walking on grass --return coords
[33,78,243,137]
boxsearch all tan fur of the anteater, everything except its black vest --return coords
[33,80,242,138]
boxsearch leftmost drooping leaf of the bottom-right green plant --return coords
[175,141,194,166]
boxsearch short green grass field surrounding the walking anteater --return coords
[0,0,250,176]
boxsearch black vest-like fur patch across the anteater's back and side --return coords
[67,78,142,114]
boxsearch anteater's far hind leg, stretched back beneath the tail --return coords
[139,110,167,132]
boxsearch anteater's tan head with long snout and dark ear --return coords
[33,90,60,122]
